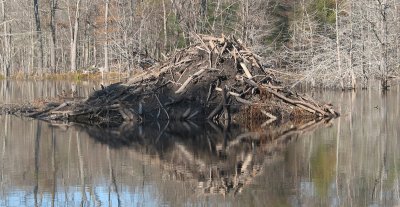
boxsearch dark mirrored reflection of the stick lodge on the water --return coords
[83,120,329,195]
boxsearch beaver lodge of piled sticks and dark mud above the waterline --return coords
[22,36,338,124]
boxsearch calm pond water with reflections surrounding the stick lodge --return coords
[0,82,400,206]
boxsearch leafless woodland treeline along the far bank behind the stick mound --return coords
[0,0,400,89]
